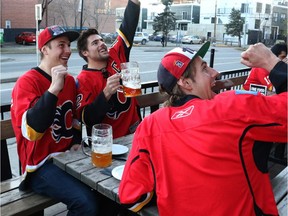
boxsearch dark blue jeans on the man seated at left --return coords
[28,160,100,216]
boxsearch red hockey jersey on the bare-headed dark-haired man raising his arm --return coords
[76,1,141,138]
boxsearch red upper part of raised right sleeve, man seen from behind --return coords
[217,90,287,142]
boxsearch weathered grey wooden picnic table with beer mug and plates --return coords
[53,134,158,216]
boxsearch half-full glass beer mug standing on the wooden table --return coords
[81,124,113,167]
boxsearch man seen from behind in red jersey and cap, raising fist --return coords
[119,42,287,216]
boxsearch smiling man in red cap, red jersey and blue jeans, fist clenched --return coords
[11,25,99,216]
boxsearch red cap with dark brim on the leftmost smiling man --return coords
[38,25,79,50]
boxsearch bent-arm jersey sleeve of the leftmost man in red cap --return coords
[12,77,57,141]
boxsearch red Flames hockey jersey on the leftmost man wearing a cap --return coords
[11,68,76,173]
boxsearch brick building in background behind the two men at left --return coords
[0,0,128,42]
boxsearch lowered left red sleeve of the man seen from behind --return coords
[119,132,155,212]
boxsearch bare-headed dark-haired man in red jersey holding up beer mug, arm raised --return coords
[77,0,141,138]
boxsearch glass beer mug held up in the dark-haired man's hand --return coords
[120,61,141,97]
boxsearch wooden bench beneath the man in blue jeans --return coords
[0,119,58,216]
